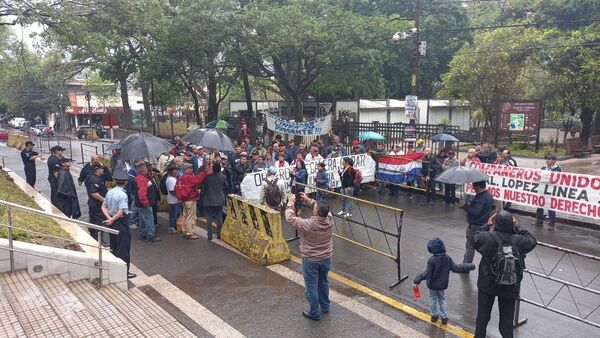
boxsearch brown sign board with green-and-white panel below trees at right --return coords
[498,101,540,133]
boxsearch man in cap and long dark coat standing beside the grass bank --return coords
[56,157,81,219]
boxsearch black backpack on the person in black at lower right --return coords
[490,231,523,286]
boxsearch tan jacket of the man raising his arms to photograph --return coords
[285,200,334,260]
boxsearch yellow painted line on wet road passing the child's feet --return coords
[292,256,473,338]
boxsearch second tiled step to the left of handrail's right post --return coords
[35,275,109,337]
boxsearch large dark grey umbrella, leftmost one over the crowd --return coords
[119,133,173,160]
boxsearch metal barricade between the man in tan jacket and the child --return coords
[287,182,408,288]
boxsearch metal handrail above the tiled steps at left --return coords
[0,200,119,288]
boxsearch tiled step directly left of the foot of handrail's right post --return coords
[68,280,143,338]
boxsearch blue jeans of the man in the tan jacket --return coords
[302,258,331,318]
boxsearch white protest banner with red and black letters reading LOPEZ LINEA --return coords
[465,163,600,223]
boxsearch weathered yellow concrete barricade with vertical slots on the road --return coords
[221,195,292,265]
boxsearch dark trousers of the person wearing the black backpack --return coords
[475,290,515,338]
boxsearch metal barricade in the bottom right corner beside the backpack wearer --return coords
[514,242,600,328]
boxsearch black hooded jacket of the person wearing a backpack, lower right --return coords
[473,210,537,299]
